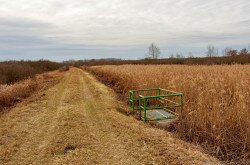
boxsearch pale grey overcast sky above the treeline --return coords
[0,0,250,61]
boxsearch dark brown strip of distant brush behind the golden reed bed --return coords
[67,52,250,67]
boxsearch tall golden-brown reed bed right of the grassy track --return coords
[87,65,250,163]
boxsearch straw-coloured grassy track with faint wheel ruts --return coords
[0,68,219,165]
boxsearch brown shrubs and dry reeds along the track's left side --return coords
[0,60,64,114]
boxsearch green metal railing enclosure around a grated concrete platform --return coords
[129,88,184,122]
